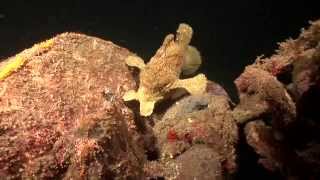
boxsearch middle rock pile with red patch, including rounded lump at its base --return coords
[145,91,238,179]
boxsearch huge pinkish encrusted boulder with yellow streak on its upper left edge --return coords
[0,33,144,179]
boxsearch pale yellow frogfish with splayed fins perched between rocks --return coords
[123,24,207,116]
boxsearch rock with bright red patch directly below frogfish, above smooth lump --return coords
[154,94,238,173]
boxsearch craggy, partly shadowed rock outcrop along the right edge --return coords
[233,20,320,179]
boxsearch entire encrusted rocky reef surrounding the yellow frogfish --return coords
[0,21,320,180]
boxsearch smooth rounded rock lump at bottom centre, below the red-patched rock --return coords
[145,145,223,180]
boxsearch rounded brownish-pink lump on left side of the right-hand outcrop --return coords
[233,66,296,129]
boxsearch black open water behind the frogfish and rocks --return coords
[0,0,320,179]
